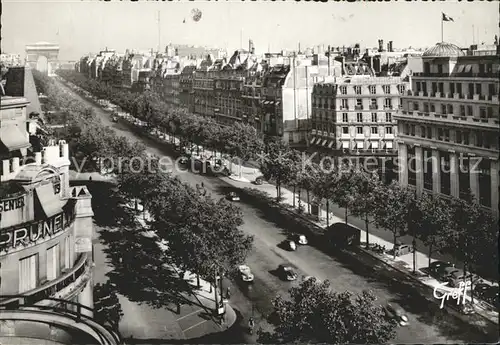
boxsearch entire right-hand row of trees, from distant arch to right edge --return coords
[62,71,498,280]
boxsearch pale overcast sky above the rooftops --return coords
[1,0,499,60]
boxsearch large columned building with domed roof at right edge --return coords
[395,42,500,215]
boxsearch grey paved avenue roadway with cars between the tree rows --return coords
[56,79,497,343]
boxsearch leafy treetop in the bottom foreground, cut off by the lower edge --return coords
[259,278,396,344]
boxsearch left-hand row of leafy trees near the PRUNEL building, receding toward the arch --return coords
[35,73,253,314]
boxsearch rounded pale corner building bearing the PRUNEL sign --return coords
[0,97,119,344]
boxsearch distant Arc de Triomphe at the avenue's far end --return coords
[26,42,59,76]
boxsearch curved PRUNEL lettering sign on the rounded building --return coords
[0,207,75,251]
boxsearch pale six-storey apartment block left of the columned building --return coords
[310,63,410,156]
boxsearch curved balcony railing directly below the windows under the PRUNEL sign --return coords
[0,253,90,306]
